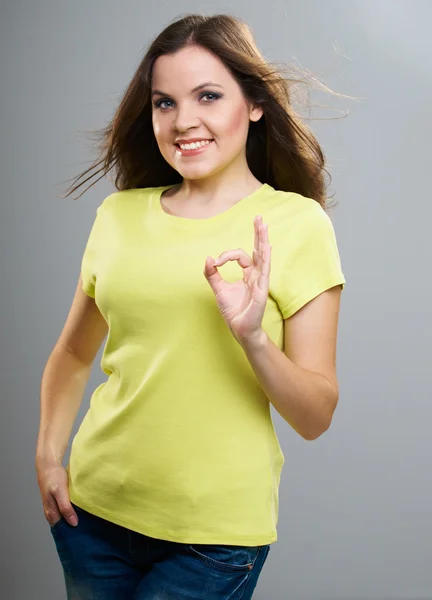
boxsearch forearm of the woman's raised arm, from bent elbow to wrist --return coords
[240,331,338,440]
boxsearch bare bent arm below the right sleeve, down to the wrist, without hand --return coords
[241,285,342,440]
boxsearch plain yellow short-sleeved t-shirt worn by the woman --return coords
[67,184,345,546]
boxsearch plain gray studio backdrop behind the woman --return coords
[0,0,432,600]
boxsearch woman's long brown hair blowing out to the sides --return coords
[63,14,348,209]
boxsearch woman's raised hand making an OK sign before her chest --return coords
[204,216,271,343]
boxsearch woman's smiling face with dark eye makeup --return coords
[152,46,262,179]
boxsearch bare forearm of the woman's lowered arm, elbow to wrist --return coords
[36,347,91,466]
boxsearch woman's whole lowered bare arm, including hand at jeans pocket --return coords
[35,276,108,526]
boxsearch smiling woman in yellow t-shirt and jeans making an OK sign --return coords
[36,10,345,600]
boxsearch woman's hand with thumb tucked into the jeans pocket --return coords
[36,463,78,527]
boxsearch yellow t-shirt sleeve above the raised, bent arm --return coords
[270,204,346,319]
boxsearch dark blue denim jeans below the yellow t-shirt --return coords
[51,504,270,600]
